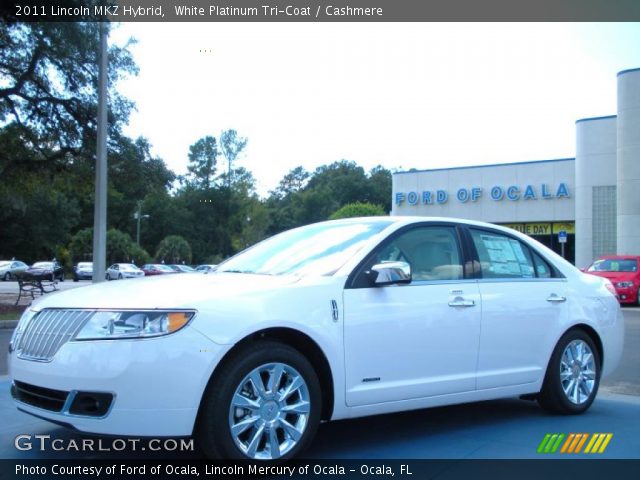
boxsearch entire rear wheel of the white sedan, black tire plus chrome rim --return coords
[538,329,601,415]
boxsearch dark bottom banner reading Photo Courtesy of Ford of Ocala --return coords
[0,460,640,480]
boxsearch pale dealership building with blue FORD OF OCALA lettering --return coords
[391,69,640,267]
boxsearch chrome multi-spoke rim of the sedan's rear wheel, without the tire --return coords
[560,340,596,405]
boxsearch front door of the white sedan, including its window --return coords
[344,225,481,406]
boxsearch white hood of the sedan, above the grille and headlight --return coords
[34,273,298,309]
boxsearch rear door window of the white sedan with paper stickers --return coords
[471,229,535,278]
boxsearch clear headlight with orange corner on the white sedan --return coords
[74,310,195,340]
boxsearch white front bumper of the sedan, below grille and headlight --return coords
[9,326,228,436]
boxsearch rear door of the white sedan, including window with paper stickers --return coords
[469,228,568,390]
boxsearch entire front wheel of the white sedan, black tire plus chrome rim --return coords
[196,341,322,463]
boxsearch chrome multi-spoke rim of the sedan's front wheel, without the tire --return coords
[229,363,311,460]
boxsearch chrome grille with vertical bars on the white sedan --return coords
[16,310,95,362]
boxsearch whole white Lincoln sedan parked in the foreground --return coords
[9,217,624,461]
